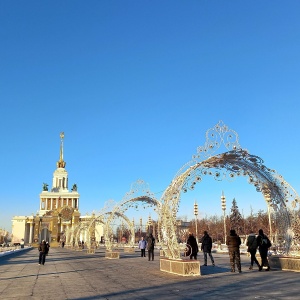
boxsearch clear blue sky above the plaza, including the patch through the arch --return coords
[0,0,300,230]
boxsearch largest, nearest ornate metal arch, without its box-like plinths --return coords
[160,121,299,259]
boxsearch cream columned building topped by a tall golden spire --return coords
[12,133,103,246]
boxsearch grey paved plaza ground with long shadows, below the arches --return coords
[0,248,300,300]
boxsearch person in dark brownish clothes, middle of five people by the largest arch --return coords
[226,229,242,273]
